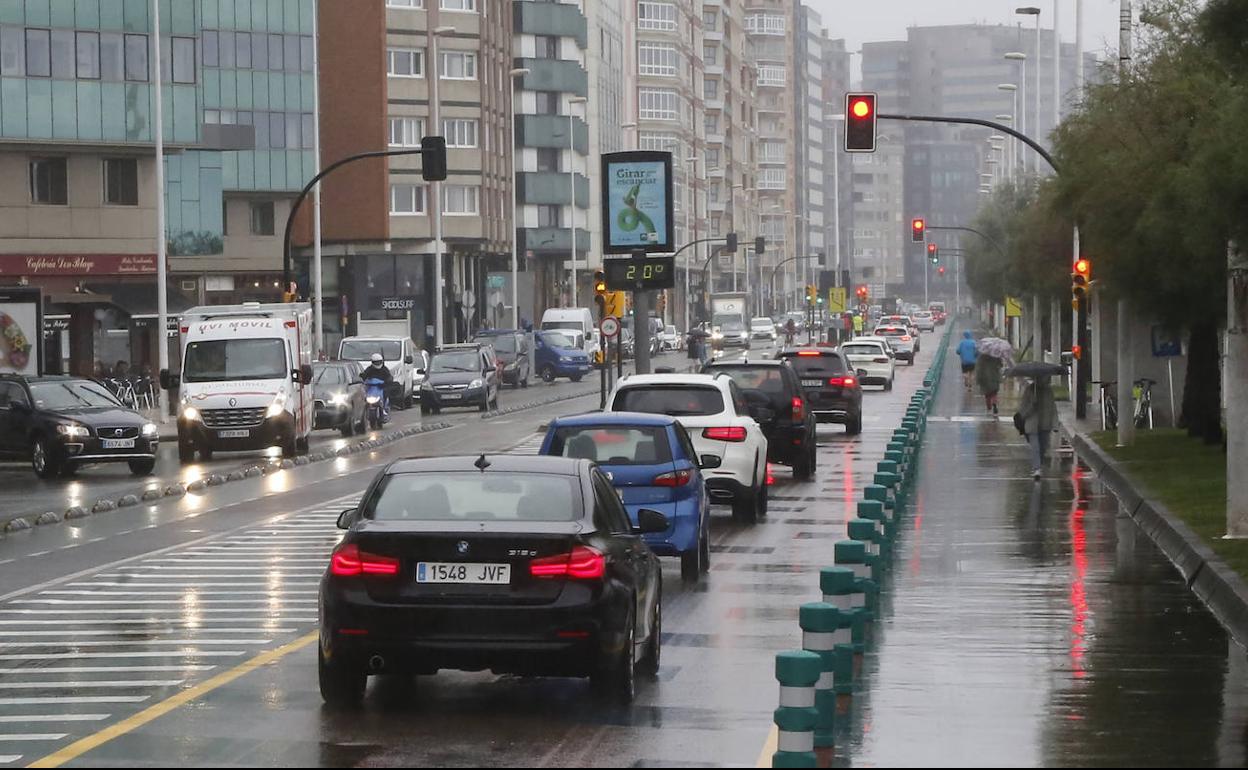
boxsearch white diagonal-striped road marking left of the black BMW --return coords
[0,495,358,766]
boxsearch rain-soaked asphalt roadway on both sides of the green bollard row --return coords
[0,326,1248,766]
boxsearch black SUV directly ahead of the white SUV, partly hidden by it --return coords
[703,359,819,480]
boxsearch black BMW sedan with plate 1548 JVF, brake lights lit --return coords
[317,456,668,705]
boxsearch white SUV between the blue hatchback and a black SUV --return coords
[607,372,768,523]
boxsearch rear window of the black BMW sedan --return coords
[363,470,582,522]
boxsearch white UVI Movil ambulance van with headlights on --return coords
[160,302,316,463]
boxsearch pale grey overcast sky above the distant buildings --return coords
[804,0,1139,71]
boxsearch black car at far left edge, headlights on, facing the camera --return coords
[0,374,160,478]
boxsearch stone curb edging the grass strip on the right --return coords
[1060,416,1248,646]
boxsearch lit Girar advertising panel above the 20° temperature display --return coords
[602,151,675,253]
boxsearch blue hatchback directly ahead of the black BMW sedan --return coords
[542,412,719,582]
